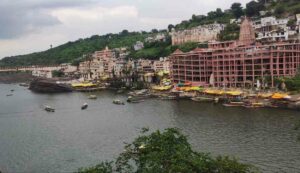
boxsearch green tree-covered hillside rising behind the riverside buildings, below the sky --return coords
[0,0,300,66]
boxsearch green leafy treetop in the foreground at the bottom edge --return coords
[78,128,257,173]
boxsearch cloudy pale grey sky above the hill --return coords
[0,0,249,59]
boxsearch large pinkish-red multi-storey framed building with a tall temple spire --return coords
[170,18,300,87]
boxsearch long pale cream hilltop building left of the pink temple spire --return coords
[171,23,225,45]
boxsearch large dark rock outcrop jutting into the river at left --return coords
[29,79,72,93]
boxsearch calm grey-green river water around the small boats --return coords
[0,84,300,173]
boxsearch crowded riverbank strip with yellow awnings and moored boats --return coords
[30,79,300,110]
